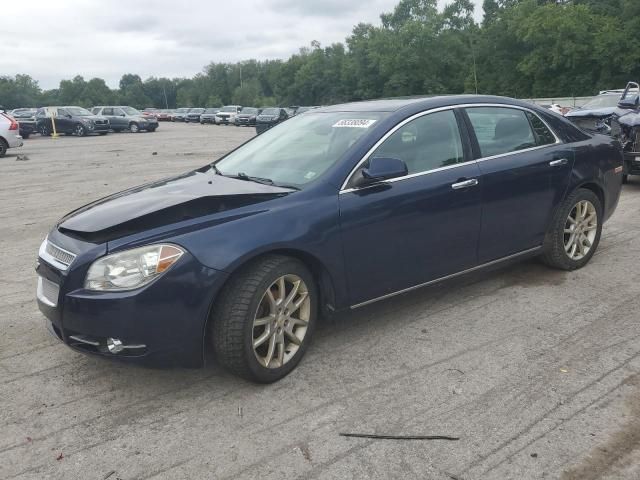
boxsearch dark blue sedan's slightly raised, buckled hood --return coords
[57,169,294,243]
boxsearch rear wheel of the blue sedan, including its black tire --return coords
[541,188,603,270]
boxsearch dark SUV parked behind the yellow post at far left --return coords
[36,106,111,137]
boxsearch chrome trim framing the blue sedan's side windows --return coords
[338,103,563,195]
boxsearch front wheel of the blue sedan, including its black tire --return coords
[209,255,318,383]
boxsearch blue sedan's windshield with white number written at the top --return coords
[215,112,388,188]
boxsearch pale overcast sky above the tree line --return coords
[0,0,482,89]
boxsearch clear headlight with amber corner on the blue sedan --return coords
[84,245,184,291]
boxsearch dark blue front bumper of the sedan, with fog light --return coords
[36,237,226,367]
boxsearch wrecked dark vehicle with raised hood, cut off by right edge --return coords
[611,82,640,180]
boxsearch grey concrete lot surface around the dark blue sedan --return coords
[0,124,640,480]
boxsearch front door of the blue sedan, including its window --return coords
[340,110,482,305]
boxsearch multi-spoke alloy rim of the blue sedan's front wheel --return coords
[251,275,311,368]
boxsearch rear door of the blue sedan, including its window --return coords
[465,106,574,264]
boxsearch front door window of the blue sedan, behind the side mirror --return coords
[371,110,464,174]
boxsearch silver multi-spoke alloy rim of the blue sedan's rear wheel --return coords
[564,200,598,260]
